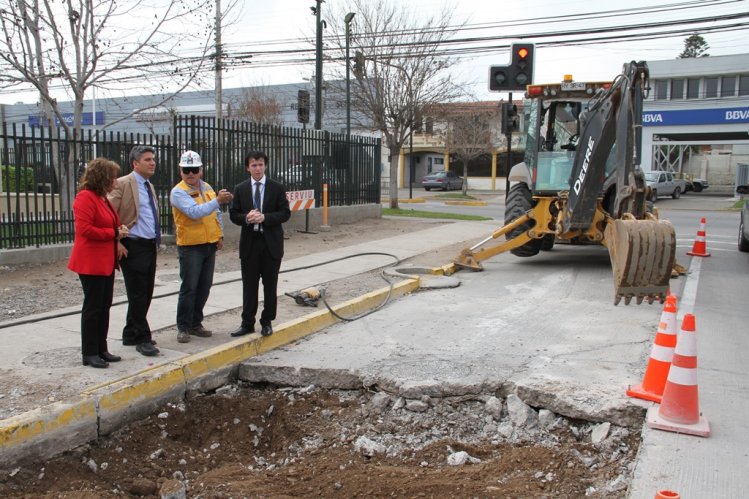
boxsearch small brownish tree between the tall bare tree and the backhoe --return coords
[441,102,500,194]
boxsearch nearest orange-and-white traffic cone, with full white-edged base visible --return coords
[647,314,710,437]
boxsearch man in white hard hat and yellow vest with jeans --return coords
[169,151,233,343]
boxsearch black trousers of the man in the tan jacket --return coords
[120,238,157,345]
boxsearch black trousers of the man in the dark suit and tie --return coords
[240,234,281,328]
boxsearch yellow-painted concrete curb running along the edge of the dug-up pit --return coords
[0,276,421,466]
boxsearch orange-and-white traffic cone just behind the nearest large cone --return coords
[627,295,676,404]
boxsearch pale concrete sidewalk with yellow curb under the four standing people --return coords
[0,221,496,466]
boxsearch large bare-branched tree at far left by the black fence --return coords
[0,0,212,210]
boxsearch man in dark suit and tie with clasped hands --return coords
[229,151,291,337]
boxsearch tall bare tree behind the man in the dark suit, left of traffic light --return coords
[326,0,463,208]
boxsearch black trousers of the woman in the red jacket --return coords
[78,272,114,357]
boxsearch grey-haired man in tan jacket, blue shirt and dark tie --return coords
[109,146,161,357]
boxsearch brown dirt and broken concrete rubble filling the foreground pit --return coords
[0,384,639,499]
